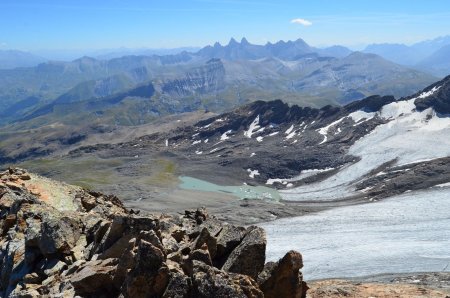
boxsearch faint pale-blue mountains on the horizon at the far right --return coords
[363,36,450,77]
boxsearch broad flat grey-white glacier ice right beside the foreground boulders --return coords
[260,186,450,280]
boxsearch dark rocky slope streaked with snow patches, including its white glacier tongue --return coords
[44,74,450,201]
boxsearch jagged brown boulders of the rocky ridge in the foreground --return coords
[0,169,307,297]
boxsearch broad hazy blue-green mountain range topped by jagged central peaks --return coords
[0,38,436,128]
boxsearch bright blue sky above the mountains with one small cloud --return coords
[0,0,450,51]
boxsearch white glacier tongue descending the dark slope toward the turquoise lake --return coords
[282,95,450,201]
